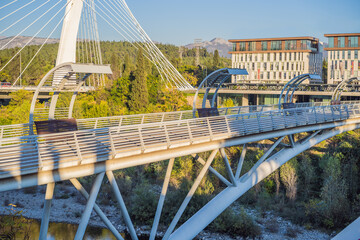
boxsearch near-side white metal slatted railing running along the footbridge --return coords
[0,104,360,178]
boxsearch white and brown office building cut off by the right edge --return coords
[324,33,360,84]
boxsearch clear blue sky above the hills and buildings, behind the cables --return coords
[0,0,360,45]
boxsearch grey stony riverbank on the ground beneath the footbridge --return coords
[0,184,330,240]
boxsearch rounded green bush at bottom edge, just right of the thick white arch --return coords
[209,208,261,239]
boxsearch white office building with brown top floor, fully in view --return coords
[229,37,323,83]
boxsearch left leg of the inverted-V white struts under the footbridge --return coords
[74,172,105,240]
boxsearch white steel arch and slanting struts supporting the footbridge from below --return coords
[34,123,360,240]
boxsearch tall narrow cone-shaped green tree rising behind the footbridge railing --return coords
[129,49,149,111]
